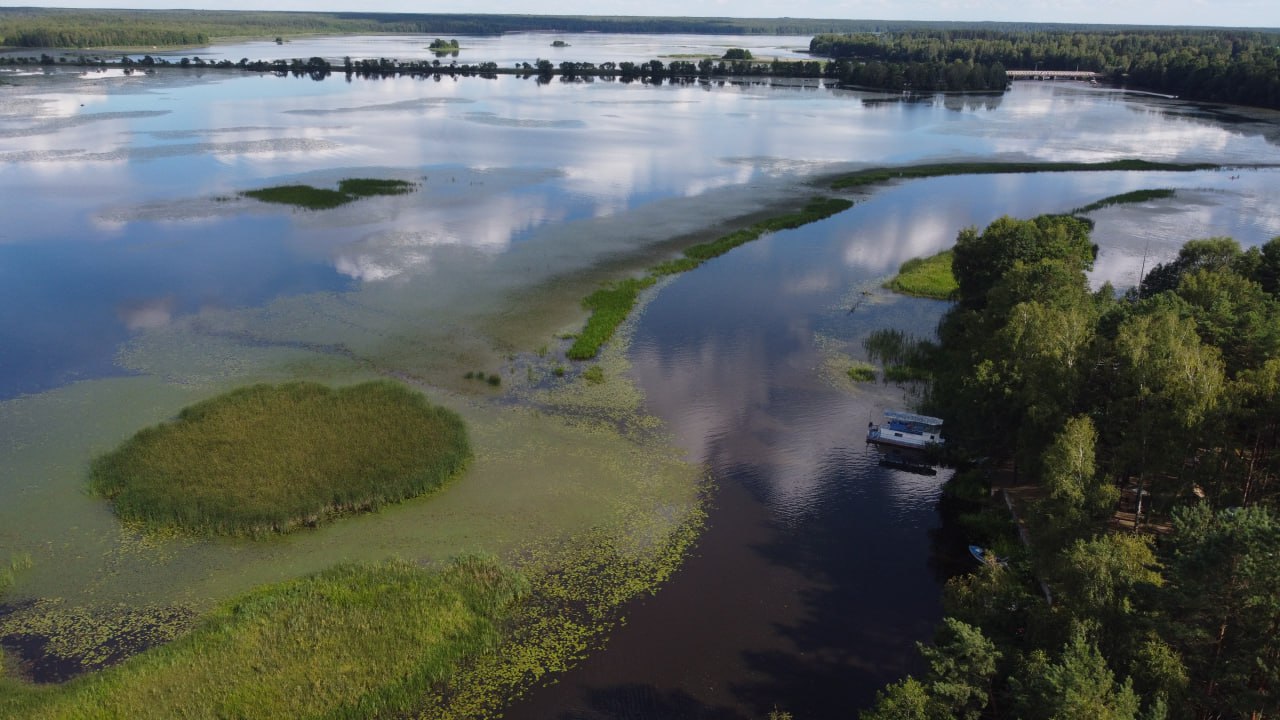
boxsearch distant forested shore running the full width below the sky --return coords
[0,8,1280,108]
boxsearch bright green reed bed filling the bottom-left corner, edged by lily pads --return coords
[0,557,527,719]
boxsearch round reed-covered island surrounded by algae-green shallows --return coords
[90,380,471,536]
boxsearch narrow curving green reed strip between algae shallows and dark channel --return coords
[566,197,854,360]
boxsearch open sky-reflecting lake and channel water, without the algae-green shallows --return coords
[0,35,1280,719]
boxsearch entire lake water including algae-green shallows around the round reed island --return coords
[0,35,1280,719]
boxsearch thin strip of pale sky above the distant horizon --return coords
[10,0,1280,28]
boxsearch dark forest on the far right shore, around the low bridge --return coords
[809,28,1280,108]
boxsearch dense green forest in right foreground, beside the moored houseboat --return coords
[861,217,1280,720]
